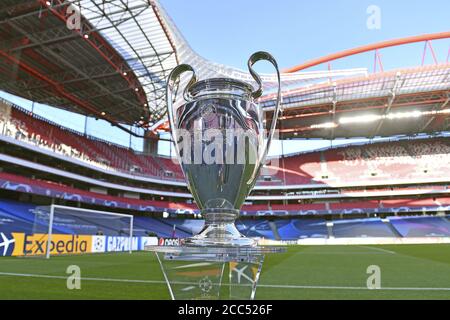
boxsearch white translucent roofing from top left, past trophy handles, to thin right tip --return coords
[73,0,367,121]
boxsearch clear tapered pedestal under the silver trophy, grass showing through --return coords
[145,246,284,300]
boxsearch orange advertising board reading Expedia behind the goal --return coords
[24,234,92,255]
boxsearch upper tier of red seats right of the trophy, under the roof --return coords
[264,138,450,185]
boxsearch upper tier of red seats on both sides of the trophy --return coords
[0,101,450,186]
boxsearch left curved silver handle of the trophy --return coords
[166,64,197,156]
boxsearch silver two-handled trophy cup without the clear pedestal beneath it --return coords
[166,51,281,247]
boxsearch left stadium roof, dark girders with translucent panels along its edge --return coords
[0,0,178,133]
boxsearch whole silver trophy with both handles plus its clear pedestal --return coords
[146,51,284,299]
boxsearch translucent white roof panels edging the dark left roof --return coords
[73,0,178,117]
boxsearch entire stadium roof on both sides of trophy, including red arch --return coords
[0,0,450,138]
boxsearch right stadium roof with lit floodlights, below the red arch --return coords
[261,64,450,139]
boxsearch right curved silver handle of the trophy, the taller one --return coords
[247,51,281,179]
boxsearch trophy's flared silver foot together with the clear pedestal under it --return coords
[145,209,285,300]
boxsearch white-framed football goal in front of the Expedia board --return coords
[30,204,133,259]
